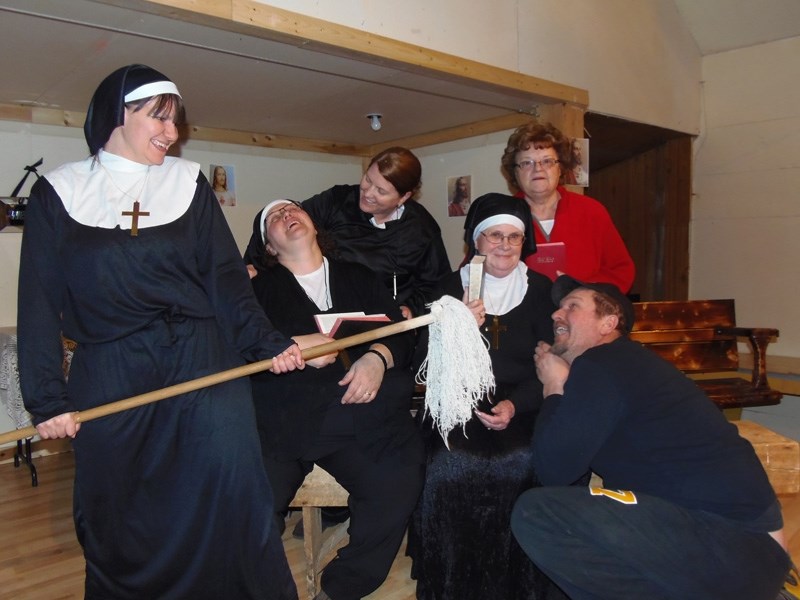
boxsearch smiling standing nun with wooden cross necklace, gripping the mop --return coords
[18,65,305,600]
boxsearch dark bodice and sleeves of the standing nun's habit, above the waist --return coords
[17,173,289,424]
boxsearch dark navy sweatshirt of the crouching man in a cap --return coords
[533,337,782,531]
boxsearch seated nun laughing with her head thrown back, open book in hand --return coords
[252,200,423,600]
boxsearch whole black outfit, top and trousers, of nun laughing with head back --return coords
[252,260,423,600]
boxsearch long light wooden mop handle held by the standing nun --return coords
[0,314,435,444]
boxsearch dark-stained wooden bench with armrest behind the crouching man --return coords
[630,300,783,409]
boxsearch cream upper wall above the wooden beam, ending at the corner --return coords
[259,0,701,133]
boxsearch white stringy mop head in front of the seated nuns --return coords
[416,296,494,449]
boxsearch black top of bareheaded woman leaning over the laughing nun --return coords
[303,185,450,316]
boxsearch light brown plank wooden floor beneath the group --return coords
[0,453,800,600]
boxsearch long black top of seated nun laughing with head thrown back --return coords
[252,261,416,458]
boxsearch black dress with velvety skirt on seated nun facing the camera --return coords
[408,271,565,600]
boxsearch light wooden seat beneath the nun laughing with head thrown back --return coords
[289,466,350,600]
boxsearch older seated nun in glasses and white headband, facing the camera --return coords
[408,194,564,600]
